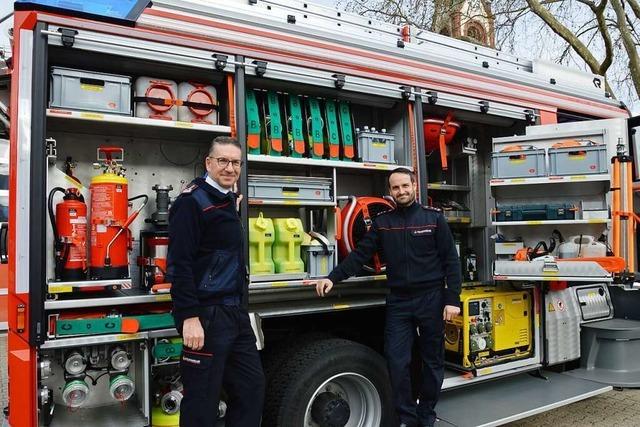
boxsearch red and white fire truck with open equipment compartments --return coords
[0,0,640,427]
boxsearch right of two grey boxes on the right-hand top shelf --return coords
[549,145,608,175]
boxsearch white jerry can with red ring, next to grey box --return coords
[133,77,178,121]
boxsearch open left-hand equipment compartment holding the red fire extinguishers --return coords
[31,25,235,426]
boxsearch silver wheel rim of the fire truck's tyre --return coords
[304,372,382,427]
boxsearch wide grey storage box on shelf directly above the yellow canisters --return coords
[248,175,333,202]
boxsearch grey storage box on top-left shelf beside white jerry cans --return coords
[49,67,131,116]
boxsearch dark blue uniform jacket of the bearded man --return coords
[329,202,462,306]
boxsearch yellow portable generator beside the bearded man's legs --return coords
[445,286,533,370]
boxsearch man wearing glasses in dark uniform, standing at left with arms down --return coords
[167,137,265,427]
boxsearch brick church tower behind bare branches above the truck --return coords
[431,0,496,48]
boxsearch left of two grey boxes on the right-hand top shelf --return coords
[491,148,547,178]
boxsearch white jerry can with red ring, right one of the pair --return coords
[178,82,218,125]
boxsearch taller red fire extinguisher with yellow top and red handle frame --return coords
[89,147,148,280]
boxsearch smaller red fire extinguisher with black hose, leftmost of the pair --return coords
[48,187,87,282]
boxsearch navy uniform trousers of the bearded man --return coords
[384,289,444,426]
